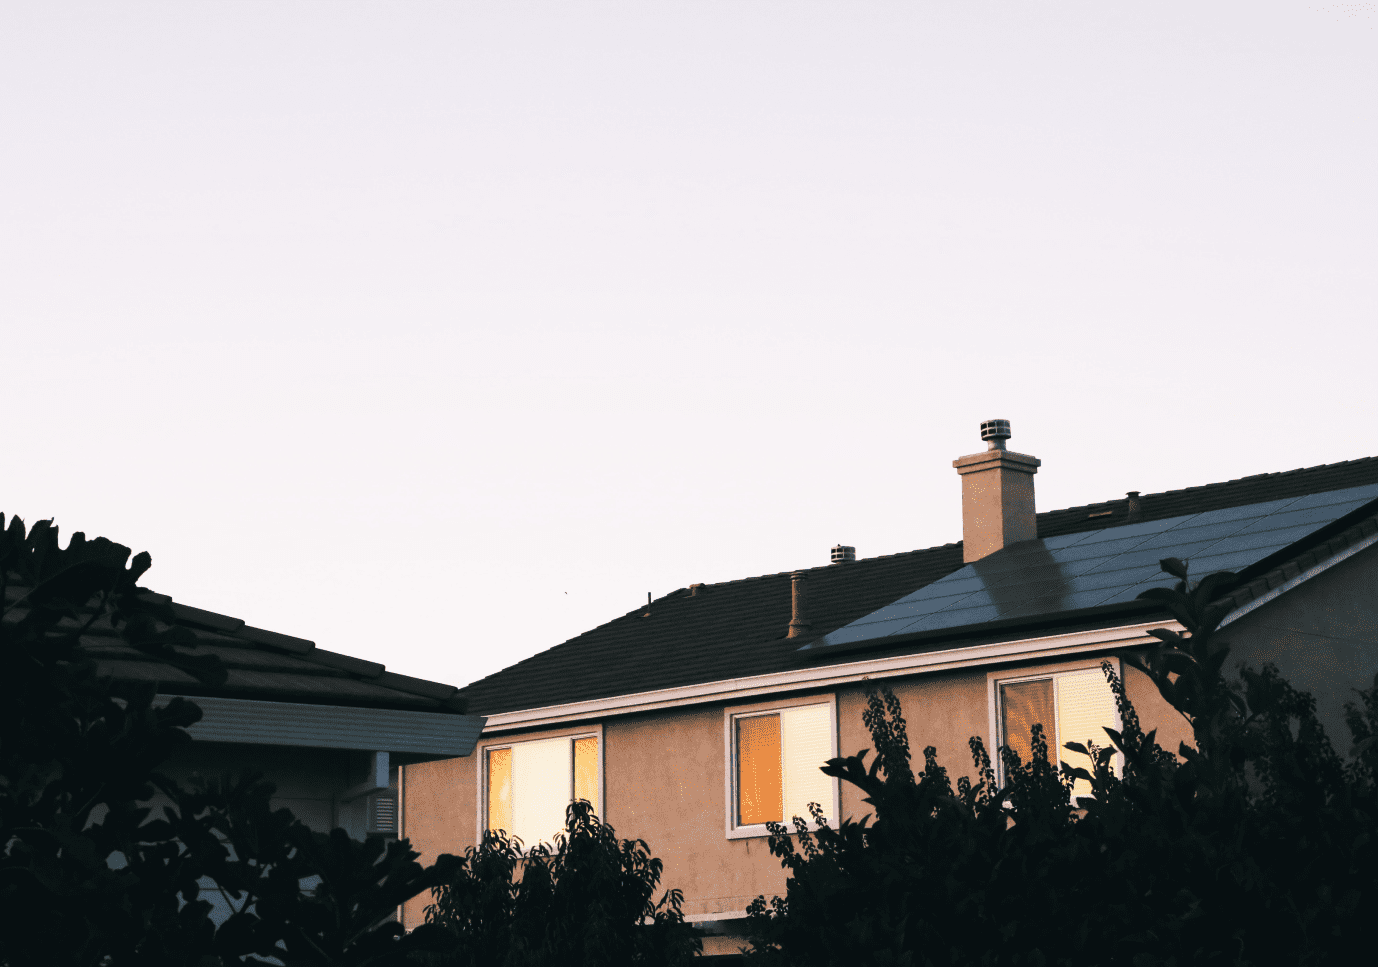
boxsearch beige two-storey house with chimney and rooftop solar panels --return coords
[401,420,1378,955]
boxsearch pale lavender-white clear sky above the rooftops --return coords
[0,0,1378,685]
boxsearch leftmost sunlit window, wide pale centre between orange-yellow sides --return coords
[484,736,602,846]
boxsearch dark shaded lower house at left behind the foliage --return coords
[83,592,484,839]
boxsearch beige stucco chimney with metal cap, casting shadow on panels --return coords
[952,420,1042,563]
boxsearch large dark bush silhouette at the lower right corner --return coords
[748,559,1378,967]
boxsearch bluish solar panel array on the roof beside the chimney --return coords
[801,484,1378,650]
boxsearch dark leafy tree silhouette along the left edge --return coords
[0,515,457,967]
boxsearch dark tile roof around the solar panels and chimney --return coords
[460,457,1378,715]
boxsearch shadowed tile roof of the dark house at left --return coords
[81,595,466,712]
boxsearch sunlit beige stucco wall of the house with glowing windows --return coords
[402,657,1185,946]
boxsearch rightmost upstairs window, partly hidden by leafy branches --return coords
[992,668,1119,799]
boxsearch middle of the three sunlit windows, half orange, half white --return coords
[728,703,836,836]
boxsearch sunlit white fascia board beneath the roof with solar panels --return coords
[484,620,1182,734]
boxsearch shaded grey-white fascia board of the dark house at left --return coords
[157,696,484,759]
